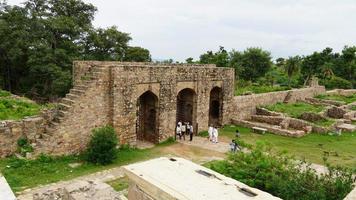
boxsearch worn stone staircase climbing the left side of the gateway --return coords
[43,66,104,137]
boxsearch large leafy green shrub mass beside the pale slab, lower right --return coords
[207,144,354,200]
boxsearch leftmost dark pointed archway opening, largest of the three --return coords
[136,91,159,143]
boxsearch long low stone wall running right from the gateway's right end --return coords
[231,86,325,119]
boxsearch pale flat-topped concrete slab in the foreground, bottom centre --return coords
[123,157,280,200]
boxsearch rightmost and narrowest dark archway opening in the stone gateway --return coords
[209,87,223,126]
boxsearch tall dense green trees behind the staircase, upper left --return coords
[0,0,151,100]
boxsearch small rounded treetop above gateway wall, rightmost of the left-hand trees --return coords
[124,47,152,62]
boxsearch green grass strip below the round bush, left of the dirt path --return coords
[0,142,172,192]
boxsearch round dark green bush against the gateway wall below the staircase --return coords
[85,126,118,165]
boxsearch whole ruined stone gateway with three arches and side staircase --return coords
[35,61,234,154]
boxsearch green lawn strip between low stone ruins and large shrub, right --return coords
[219,126,356,170]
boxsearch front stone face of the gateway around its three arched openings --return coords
[113,65,234,144]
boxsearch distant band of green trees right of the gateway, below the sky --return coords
[193,46,356,89]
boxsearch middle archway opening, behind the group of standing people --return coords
[176,88,197,127]
